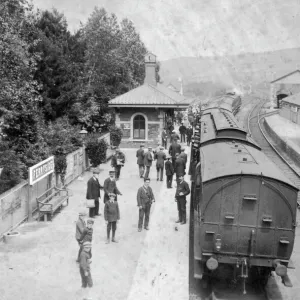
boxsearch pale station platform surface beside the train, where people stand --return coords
[0,147,189,300]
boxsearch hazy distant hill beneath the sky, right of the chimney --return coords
[160,48,300,96]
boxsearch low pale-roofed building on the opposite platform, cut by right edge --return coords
[279,93,300,125]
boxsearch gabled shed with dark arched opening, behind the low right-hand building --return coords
[270,70,300,108]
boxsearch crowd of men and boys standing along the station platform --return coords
[76,124,190,296]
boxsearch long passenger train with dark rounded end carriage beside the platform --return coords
[189,94,298,293]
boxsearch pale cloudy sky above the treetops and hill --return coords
[32,0,300,61]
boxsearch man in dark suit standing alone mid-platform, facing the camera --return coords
[137,178,155,231]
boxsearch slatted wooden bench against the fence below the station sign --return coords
[36,186,69,221]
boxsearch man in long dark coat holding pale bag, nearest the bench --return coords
[86,169,103,218]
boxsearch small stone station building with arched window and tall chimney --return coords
[108,53,190,148]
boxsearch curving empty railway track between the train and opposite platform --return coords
[248,101,300,207]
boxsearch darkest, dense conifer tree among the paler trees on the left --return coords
[34,9,85,120]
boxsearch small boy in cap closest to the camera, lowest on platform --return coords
[79,242,93,288]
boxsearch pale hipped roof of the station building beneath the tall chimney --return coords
[108,83,192,108]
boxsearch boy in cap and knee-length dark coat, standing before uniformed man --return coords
[104,193,120,244]
